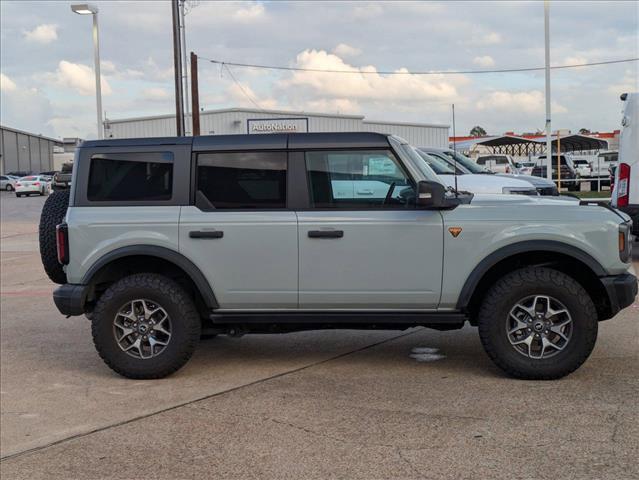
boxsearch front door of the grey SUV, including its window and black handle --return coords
[297,149,443,311]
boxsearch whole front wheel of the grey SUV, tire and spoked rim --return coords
[478,267,598,380]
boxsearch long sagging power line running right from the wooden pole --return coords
[200,57,639,76]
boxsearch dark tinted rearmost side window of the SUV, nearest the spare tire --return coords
[87,152,173,202]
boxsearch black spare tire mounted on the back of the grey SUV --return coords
[40,190,70,284]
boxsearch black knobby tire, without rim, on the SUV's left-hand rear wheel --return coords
[91,273,202,380]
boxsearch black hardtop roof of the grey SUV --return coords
[81,132,389,151]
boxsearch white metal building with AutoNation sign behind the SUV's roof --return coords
[105,108,449,148]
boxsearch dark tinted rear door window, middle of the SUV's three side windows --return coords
[195,152,286,210]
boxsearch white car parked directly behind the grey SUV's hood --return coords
[417,148,538,196]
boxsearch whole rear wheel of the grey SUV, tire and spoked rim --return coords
[91,273,201,379]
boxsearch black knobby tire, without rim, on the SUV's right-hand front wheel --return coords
[478,267,598,380]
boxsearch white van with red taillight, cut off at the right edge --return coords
[612,92,639,236]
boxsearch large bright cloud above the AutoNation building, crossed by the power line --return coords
[280,50,467,104]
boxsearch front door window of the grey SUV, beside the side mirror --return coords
[306,150,414,208]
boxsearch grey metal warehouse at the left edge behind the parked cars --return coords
[0,127,61,174]
